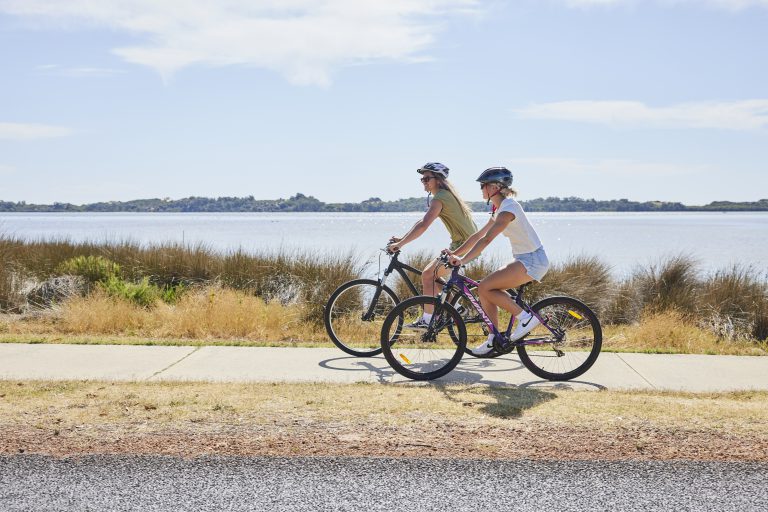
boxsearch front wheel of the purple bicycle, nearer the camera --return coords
[381,295,467,380]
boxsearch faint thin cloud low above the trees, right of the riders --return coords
[509,157,706,177]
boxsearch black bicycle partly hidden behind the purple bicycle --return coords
[323,249,492,357]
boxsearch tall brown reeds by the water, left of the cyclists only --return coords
[0,235,362,322]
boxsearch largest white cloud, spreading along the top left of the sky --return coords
[0,0,479,85]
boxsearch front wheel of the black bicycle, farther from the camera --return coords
[323,279,399,357]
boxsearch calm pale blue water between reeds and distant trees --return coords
[0,213,768,274]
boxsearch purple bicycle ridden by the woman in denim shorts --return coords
[381,257,603,381]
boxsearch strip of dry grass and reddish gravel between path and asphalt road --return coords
[0,382,768,460]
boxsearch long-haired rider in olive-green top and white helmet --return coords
[387,162,477,328]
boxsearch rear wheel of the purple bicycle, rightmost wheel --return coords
[517,297,603,380]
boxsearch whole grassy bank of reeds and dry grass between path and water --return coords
[0,237,768,354]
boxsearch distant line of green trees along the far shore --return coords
[0,193,768,213]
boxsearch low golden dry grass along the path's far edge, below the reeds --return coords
[0,287,768,355]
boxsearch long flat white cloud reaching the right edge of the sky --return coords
[514,99,768,130]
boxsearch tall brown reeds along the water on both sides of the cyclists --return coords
[0,236,768,342]
